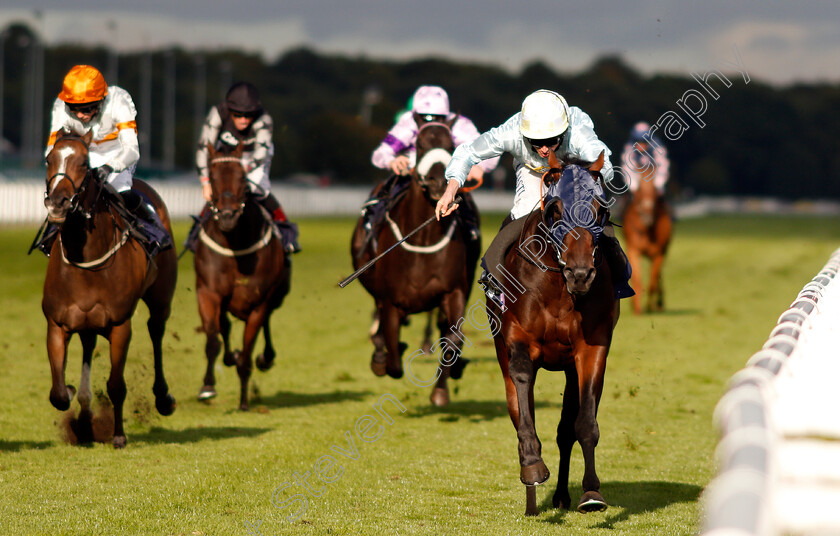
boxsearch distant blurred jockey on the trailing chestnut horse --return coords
[621,122,671,196]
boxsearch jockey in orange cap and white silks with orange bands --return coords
[37,65,172,256]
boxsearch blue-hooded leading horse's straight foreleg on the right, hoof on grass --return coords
[575,347,607,512]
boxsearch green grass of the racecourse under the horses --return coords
[0,216,840,535]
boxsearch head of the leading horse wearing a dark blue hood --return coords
[543,152,608,296]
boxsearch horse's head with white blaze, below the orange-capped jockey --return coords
[44,129,93,223]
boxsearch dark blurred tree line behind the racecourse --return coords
[0,21,840,198]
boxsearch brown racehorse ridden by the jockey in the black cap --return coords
[194,143,291,411]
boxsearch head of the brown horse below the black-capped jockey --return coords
[207,143,248,232]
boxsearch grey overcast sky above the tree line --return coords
[0,0,840,84]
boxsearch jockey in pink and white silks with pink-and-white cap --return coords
[362,86,499,240]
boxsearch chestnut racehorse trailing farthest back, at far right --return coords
[624,170,673,314]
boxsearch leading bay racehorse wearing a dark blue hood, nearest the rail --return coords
[487,153,619,515]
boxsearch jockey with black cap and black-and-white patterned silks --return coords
[186,82,301,253]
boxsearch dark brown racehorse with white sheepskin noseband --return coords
[350,120,480,406]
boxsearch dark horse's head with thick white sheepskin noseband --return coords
[413,114,457,204]
